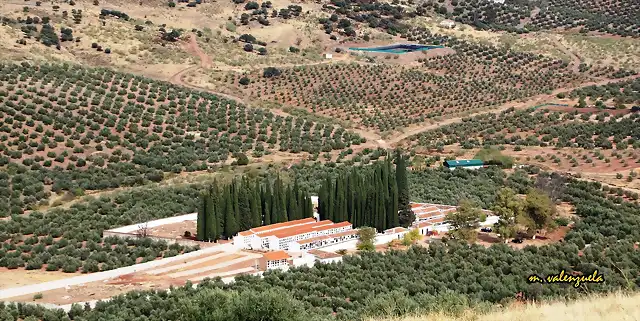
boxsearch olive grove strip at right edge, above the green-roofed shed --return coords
[413,108,640,149]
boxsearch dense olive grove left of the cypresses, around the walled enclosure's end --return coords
[0,182,202,272]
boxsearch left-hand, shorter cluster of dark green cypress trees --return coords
[196,176,313,241]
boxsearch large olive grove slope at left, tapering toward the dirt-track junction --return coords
[0,63,365,215]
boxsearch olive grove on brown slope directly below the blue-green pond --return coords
[225,28,634,132]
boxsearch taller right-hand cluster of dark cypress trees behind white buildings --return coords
[318,151,414,231]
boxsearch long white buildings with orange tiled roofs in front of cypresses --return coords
[233,218,356,251]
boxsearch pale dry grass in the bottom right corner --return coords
[370,293,640,321]
